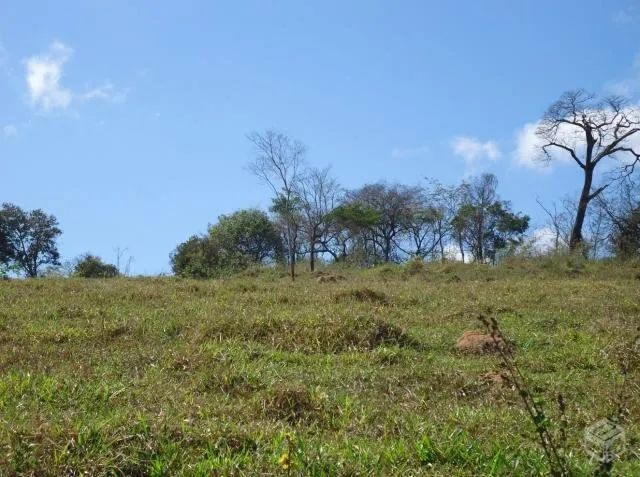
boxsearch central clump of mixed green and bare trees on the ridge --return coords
[171,131,529,277]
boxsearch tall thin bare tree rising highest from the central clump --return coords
[247,130,307,280]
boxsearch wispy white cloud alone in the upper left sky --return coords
[26,41,126,111]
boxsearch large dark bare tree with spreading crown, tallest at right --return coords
[536,90,640,250]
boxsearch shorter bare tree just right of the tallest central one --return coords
[295,167,342,271]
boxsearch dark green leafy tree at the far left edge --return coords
[0,203,62,277]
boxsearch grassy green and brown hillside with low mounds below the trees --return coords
[0,259,640,476]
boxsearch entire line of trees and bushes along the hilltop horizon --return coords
[5,90,640,278]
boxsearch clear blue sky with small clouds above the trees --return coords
[0,0,640,274]
